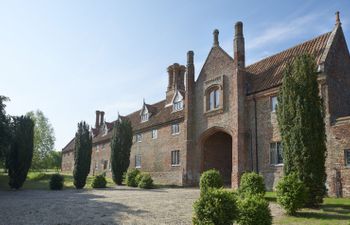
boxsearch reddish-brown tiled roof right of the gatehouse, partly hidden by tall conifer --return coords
[246,32,331,94]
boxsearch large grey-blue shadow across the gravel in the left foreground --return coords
[0,190,148,225]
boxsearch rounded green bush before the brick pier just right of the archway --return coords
[238,172,266,197]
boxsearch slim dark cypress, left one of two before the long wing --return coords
[73,121,92,189]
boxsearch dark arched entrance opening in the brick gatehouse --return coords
[202,130,232,185]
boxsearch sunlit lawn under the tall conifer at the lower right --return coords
[265,192,350,225]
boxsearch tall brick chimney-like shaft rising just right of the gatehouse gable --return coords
[233,21,245,68]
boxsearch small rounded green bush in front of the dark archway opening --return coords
[199,169,224,193]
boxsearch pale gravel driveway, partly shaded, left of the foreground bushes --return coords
[0,187,199,225]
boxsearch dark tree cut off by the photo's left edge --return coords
[0,95,11,161]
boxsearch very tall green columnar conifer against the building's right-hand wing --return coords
[277,55,326,206]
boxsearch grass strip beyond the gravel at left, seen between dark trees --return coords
[0,172,115,190]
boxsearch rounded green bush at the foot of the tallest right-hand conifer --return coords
[276,173,307,215]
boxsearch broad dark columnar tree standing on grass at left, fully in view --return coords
[7,116,34,189]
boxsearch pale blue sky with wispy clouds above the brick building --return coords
[0,0,350,150]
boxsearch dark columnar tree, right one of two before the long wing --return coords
[111,118,132,185]
